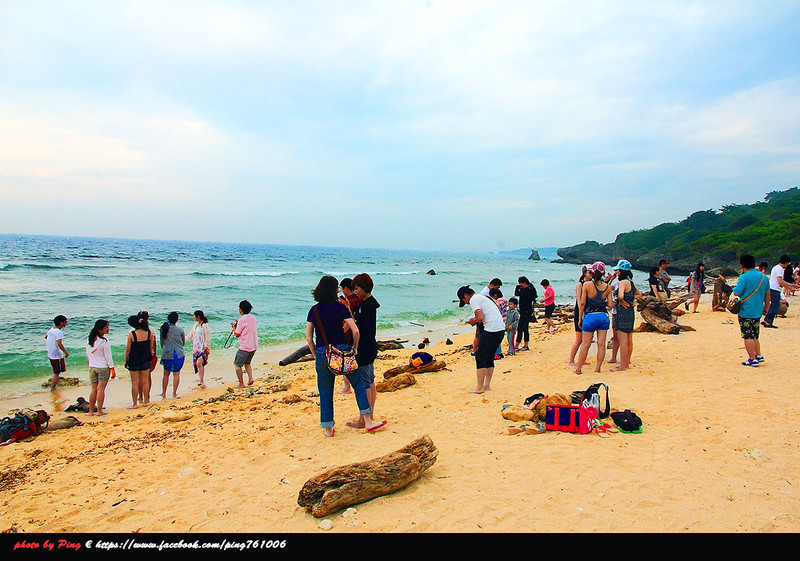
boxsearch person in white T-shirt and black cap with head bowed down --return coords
[456,286,506,394]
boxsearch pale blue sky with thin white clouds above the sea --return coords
[0,0,800,252]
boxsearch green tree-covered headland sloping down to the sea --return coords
[558,187,800,272]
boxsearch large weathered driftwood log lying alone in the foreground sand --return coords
[297,434,439,518]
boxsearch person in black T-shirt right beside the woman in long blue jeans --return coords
[345,273,381,429]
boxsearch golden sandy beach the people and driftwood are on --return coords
[0,288,800,533]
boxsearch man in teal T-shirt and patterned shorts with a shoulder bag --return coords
[733,255,771,366]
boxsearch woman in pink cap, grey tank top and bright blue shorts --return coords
[575,261,613,374]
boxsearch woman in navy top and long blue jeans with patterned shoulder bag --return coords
[306,275,386,436]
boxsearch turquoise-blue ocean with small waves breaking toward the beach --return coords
[0,234,580,398]
